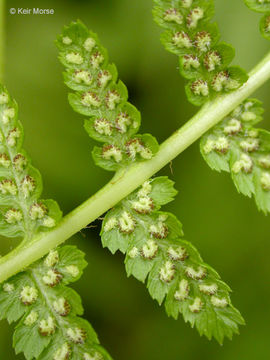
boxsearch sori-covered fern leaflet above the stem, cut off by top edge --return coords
[153,0,248,106]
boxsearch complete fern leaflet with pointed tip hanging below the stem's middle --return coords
[101,177,244,343]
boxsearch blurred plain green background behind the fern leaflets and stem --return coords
[0,0,270,360]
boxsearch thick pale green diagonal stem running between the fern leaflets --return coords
[0,52,270,282]
